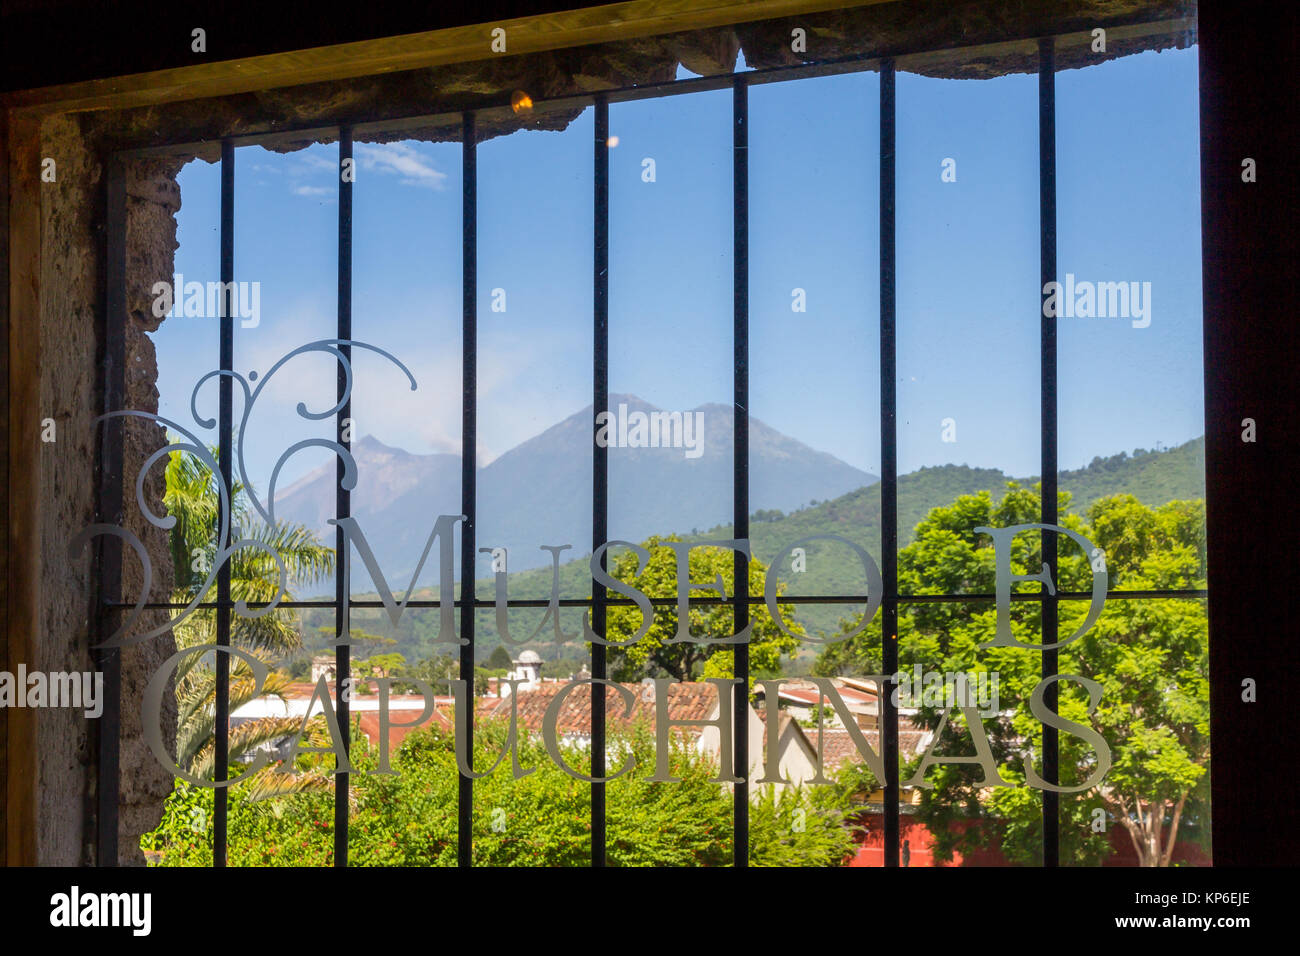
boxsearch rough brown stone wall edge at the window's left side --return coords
[31,116,181,866]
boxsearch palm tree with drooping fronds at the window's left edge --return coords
[163,449,334,800]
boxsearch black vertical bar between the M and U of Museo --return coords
[456,113,478,866]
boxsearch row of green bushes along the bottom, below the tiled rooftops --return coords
[140,721,861,868]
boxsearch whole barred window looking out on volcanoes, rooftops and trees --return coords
[91,3,1208,866]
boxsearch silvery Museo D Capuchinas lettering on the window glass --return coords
[142,515,1110,793]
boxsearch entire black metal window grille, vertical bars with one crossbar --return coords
[96,26,1208,866]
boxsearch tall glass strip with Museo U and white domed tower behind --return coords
[475,109,594,866]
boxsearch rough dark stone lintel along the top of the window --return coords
[89,0,1196,159]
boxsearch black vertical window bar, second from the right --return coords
[880,60,900,866]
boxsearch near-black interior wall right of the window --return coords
[1200,1,1300,866]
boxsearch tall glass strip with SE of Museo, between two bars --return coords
[607,90,735,866]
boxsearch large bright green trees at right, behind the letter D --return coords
[818,483,1209,865]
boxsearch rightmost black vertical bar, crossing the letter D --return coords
[1039,36,1061,866]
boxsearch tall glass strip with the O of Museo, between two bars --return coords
[749,73,880,866]
